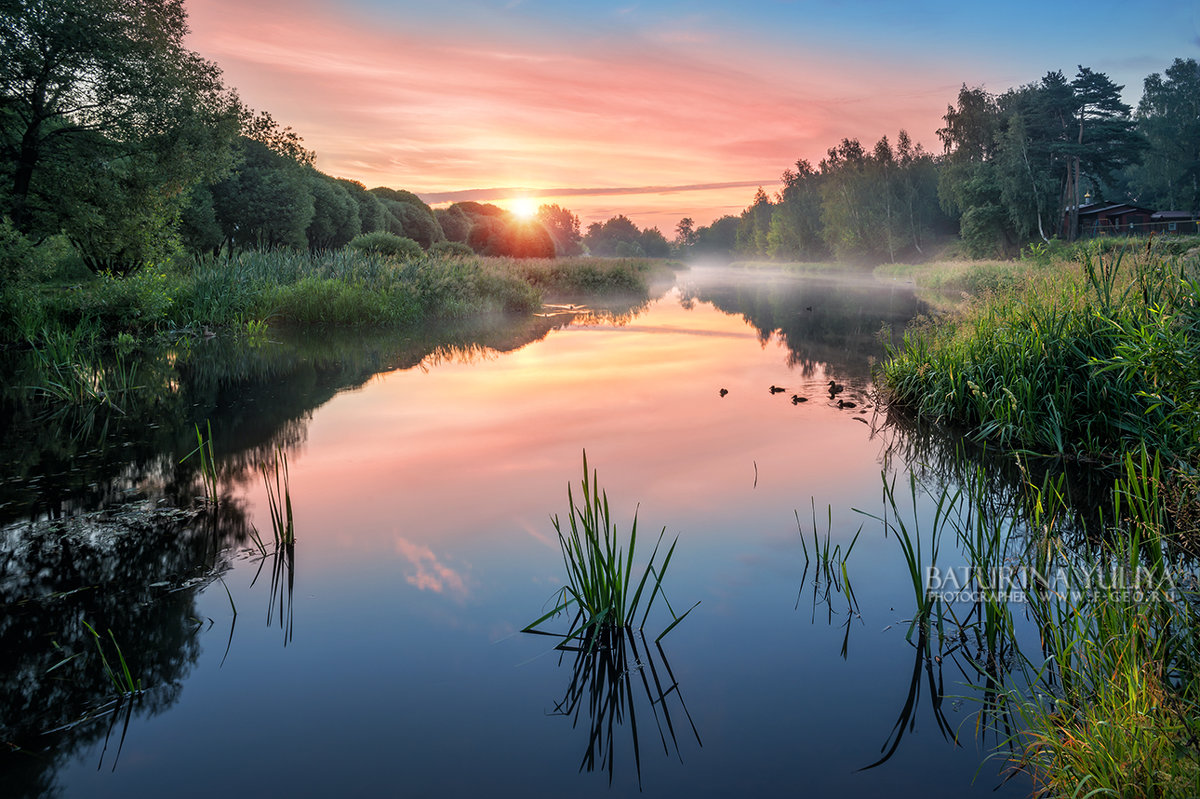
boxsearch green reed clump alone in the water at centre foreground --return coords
[524,451,700,641]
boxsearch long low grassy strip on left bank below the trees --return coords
[0,250,670,342]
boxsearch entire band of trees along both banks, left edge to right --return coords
[0,0,1200,274]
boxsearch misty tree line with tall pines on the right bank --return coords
[673,59,1200,262]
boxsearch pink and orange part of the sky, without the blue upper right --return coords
[187,0,1185,232]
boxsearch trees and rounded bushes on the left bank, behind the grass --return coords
[0,0,670,275]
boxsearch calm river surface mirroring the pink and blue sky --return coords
[0,270,1030,798]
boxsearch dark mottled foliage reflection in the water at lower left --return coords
[0,505,231,797]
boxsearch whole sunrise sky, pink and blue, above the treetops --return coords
[180,0,1198,230]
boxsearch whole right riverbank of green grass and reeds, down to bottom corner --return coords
[880,241,1200,797]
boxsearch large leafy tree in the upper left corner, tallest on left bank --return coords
[0,0,241,265]
